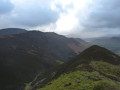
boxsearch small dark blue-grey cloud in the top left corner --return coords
[0,0,14,14]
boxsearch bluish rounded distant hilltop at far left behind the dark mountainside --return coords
[0,28,27,36]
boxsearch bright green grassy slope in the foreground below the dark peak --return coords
[37,61,120,90]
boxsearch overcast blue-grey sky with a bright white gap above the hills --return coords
[0,0,120,38]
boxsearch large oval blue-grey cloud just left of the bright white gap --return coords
[11,0,59,26]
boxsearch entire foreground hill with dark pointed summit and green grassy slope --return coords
[25,46,120,90]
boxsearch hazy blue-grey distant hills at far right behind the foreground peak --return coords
[90,37,120,55]
